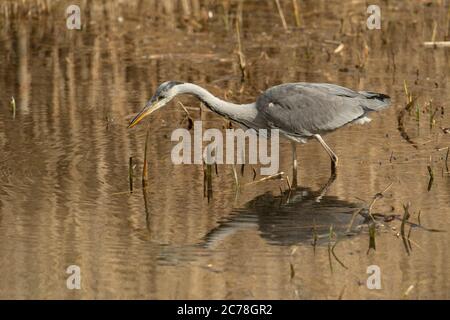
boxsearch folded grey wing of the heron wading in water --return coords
[257,83,388,137]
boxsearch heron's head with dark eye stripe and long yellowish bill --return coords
[128,81,183,128]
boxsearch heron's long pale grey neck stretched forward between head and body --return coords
[177,83,257,123]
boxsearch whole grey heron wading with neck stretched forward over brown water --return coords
[128,81,390,186]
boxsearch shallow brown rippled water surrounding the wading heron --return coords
[0,1,450,299]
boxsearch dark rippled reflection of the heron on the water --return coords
[201,176,367,248]
